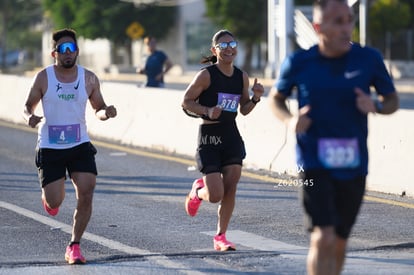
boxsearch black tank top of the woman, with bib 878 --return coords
[198,65,243,122]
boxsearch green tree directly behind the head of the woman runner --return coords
[205,0,267,72]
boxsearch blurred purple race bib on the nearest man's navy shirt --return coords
[318,138,360,168]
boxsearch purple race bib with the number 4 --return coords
[49,124,81,144]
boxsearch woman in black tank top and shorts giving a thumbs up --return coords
[182,30,264,251]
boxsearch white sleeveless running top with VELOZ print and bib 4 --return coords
[38,65,90,149]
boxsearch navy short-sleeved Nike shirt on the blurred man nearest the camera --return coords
[275,44,395,179]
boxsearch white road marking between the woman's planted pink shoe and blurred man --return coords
[201,230,308,255]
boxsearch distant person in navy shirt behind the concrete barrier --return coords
[138,36,173,87]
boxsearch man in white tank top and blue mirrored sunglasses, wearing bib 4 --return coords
[24,29,116,264]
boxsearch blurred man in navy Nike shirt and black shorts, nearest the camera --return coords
[270,0,399,274]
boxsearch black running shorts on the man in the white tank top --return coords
[35,142,98,187]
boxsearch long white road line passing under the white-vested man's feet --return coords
[0,201,203,275]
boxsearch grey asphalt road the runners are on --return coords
[0,121,414,275]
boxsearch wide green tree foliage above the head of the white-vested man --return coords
[42,0,176,64]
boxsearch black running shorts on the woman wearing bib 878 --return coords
[196,121,246,174]
